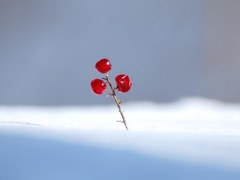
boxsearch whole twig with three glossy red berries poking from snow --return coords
[91,58,132,130]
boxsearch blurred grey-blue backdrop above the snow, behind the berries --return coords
[0,0,240,105]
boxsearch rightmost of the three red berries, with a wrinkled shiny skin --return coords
[115,74,132,93]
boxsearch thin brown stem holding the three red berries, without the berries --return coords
[104,74,128,130]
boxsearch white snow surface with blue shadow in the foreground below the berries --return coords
[0,98,240,180]
